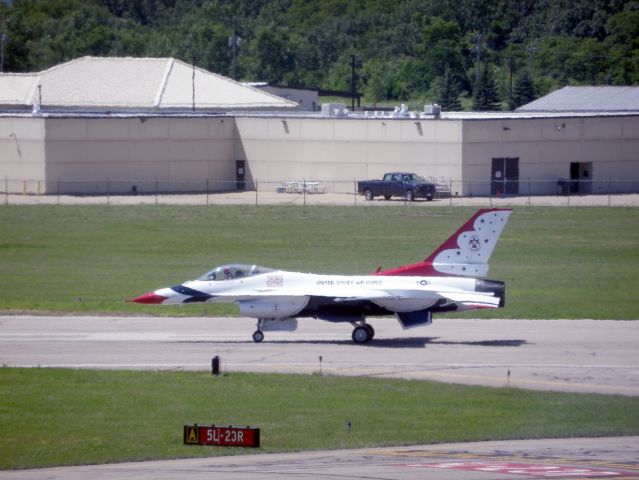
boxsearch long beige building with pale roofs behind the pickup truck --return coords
[0,57,639,196]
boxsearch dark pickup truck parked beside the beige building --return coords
[357,172,435,202]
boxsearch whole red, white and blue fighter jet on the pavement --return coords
[131,209,511,343]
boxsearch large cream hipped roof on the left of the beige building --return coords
[0,57,297,111]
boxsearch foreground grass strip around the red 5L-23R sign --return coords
[0,368,639,469]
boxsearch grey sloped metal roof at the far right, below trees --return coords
[516,86,639,112]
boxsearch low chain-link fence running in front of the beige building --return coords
[0,178,639,206]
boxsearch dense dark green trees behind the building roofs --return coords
[0,0,639,110]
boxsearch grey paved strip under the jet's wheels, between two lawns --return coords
[0,315,639,396]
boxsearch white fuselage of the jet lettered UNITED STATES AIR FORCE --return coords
[155,270,499,318]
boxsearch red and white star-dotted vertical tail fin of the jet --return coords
[376,208,512,277]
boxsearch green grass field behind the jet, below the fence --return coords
[0,205,639,319]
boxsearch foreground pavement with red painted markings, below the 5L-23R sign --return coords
[0,437,639,480]
